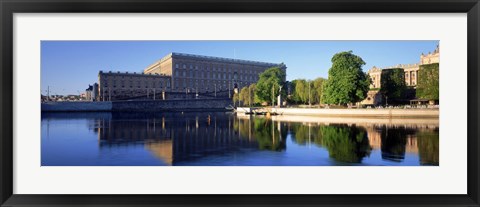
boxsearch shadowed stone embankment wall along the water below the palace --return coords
[42,99,232,112]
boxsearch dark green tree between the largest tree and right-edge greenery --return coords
[380,68,407,101]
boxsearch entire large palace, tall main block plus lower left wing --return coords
[96,53,287,101]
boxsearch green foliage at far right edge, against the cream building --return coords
[417,63,439,100]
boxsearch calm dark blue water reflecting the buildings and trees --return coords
[41,112,439,166]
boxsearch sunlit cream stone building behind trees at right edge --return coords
[361,45,440,105]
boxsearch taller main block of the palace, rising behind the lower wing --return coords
[144,53,286,93]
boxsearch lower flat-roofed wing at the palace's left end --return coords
[98,71,171,101]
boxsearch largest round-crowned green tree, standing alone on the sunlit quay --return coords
[322,51,371,105]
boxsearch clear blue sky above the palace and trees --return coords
[41,41,439,95]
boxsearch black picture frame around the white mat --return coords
[0,0,480,206]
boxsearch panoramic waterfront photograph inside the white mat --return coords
[40,40,440,167]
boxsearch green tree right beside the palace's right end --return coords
[255,67,286,103]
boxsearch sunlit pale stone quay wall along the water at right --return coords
[237,107,439,118]
